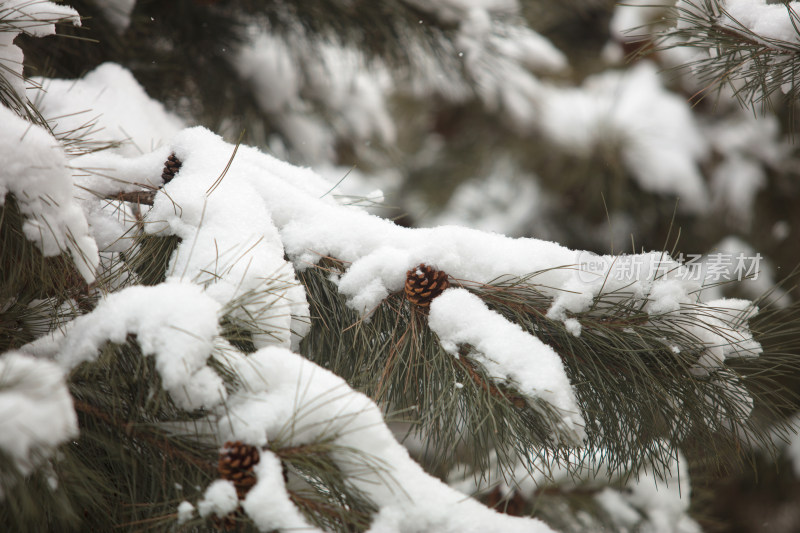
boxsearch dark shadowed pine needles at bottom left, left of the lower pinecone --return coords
[0,338,216,531]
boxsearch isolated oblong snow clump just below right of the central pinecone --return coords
[428,288,584,442]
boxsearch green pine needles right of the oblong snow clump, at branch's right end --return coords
[476,278,798,472]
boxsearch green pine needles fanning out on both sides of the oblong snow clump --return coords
[302,260,798,484]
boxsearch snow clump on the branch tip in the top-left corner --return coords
[0,0,81,111]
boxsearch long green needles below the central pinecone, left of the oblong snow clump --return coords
[301,264,560,478]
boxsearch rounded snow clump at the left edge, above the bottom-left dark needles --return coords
[0,351,78,488]
